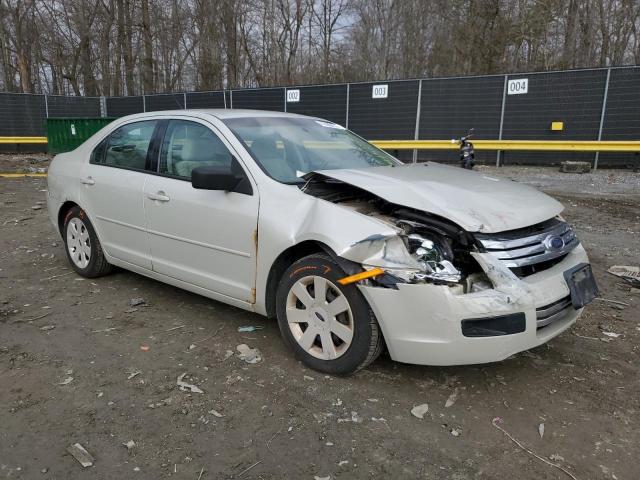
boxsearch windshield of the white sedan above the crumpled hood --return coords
[224,117,399,183]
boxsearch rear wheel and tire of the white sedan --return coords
[62,206,113,278]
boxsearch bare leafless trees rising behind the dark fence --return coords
[0,0,640,96]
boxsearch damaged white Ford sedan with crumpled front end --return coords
[48,110,597,374]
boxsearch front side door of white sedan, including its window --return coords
[144,120,258,303]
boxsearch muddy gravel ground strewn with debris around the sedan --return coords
[0,158,640,480]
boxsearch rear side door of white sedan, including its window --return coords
[81,120,160,270]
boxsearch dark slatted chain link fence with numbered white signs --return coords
[0,66,640,167]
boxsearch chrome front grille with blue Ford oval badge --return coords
[476,219,580,268]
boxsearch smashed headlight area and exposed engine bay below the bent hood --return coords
[304,174,492,293]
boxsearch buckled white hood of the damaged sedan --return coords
[305,162,564,233]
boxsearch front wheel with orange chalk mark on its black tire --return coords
[276,254,384,375]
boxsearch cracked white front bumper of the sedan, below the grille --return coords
[359,245,588,365]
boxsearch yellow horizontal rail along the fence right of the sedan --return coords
[371,140,640,152]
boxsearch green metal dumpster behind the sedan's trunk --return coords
[47,117,115,153]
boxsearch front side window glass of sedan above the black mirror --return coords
[160,120,233,180]
